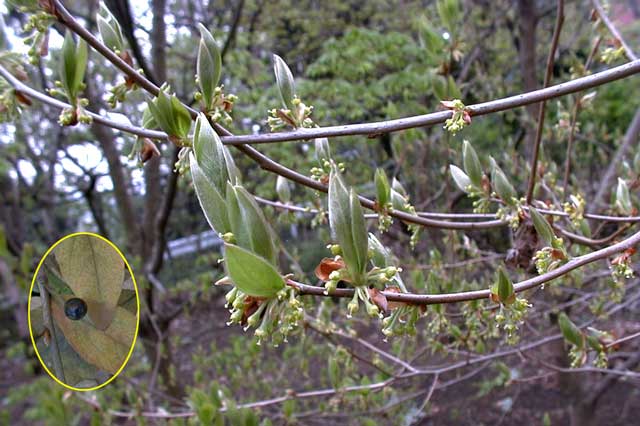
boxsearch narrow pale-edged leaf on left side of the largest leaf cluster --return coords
[189,154,231,235]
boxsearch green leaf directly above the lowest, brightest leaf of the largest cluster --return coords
[227,184,278,265]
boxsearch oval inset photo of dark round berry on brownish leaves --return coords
[29,232,140,390]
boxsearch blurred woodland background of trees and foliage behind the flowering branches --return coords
[0,0,640,425]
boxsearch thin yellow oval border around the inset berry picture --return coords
[27,232,140,392]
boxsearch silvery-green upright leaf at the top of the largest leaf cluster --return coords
[193,113,229,193]
